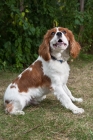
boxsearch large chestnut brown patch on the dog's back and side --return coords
[13,61,51,92]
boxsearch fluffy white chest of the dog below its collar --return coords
[43,60,70,84]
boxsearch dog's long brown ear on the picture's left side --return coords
[39,32,51,61]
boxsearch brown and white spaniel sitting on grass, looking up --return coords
[4,27,84,115]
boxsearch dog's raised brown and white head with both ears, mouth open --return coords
[39,27,81,61]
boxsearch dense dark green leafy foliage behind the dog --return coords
[0,0,93,70]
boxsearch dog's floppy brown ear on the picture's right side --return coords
[69,31,81,58]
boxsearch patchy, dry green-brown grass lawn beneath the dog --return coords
[0,60,93,140]
